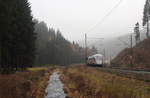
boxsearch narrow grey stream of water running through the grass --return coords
[45,72,66,98]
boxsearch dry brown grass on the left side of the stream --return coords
[0,68,54,98]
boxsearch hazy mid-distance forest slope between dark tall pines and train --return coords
[34,20,85,66]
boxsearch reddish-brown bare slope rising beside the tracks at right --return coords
[112,39,150,70]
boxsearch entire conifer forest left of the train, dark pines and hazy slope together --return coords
[0,0,97,73]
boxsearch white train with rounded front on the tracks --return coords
[87,54,103,67]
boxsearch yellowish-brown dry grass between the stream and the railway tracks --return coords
[61,67,150,98]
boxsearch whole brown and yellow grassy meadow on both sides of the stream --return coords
[0,66,150,98]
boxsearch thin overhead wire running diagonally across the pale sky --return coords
[86,0,123,33]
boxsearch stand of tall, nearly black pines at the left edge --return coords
[0,0,36,70]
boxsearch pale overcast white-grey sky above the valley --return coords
[29,0,145,41]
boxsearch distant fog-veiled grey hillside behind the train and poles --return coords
[85,29,146,60]
